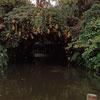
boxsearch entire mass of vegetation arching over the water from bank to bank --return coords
[0,0,100,71]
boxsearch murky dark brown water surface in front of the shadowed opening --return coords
[0,64,100,100]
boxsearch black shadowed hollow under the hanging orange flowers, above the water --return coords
[8,39,66,63]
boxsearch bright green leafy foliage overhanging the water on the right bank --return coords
[69,4,100,70]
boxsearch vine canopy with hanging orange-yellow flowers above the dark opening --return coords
[0,5,71,47]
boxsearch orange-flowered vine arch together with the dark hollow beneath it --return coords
[0,3,71,63]
